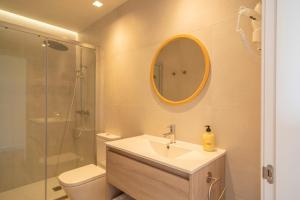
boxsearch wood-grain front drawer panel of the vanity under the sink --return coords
[107,150,189,200]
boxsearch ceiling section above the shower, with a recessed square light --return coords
[0,0,127,32]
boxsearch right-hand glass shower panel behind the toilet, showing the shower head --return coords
[47,43,95,200]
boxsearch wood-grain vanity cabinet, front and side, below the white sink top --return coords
[106,148,225,200]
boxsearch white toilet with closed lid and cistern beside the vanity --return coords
[58,133,120,200]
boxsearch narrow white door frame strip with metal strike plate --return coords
[261,0,277,200]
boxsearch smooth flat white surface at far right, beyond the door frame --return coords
[276,0,300,200]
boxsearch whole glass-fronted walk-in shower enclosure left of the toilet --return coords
[0,26,96,200]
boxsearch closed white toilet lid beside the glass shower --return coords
[58,164,105,186]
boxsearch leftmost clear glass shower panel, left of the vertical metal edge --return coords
[0,28,46,200]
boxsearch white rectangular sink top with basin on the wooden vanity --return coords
[106,135,225,174]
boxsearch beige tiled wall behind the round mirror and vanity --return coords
[81,0,261,200]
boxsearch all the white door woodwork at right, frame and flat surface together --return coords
[262,0,300,200]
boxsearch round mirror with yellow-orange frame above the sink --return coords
[150,35,210,104]
